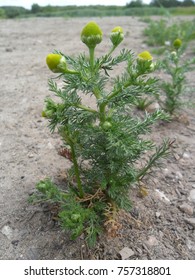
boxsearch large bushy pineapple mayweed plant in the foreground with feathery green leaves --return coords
[33,22,170,245]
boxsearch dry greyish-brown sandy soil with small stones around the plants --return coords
[0,17,195,260]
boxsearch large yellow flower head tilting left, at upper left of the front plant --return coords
[46,53,67,73]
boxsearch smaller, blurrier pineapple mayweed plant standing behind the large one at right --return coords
[160,38,195,115]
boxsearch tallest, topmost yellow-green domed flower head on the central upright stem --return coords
[81,21,103,48]
